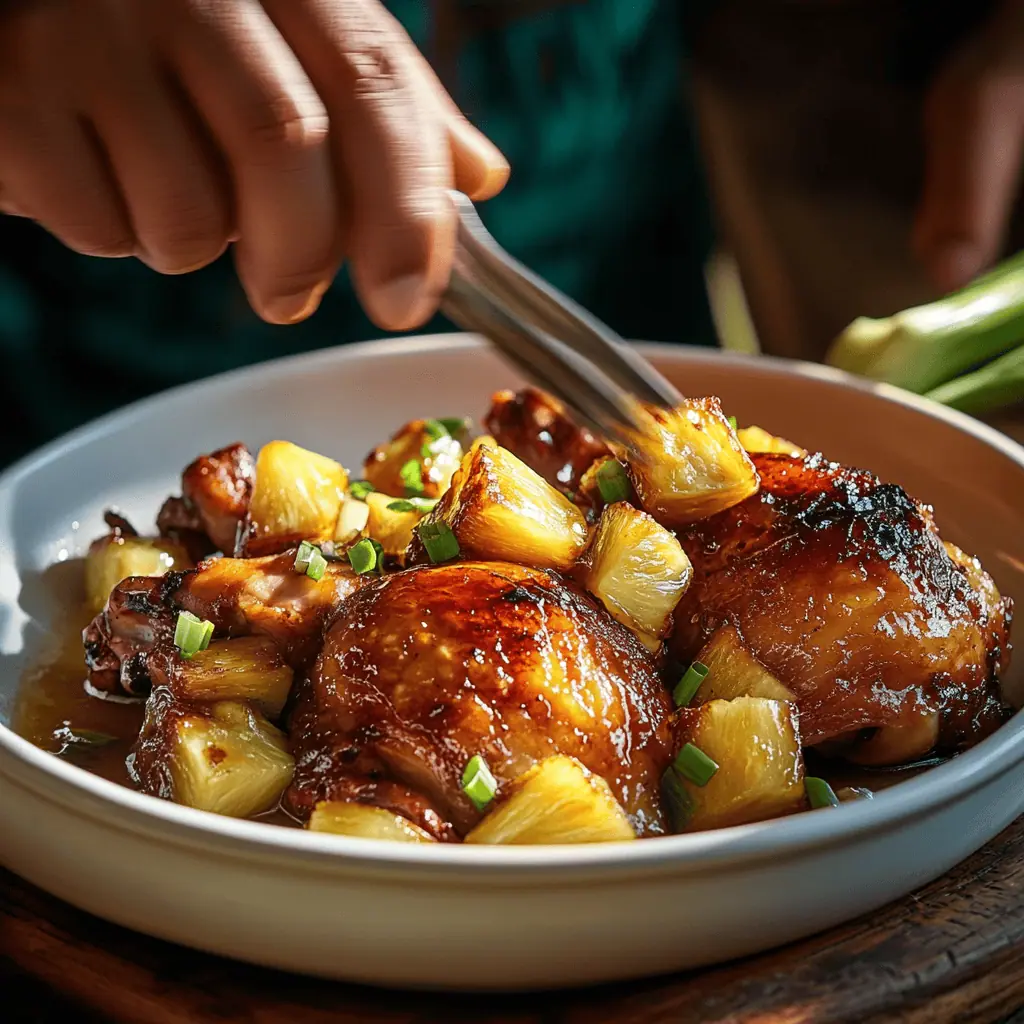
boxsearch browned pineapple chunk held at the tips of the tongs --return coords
[618,398,760,529]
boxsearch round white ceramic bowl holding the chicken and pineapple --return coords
[0,338,1024,988]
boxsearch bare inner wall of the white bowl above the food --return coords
[0,338,1024,724]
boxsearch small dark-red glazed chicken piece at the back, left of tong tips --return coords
[484,387,611,499]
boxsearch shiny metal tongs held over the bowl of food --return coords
[440,193,682,445]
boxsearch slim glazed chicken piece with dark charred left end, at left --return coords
[83,552,360,695]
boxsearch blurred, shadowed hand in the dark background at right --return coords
[912,0,1024,292]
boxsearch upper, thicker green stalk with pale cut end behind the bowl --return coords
[826,253,1024,395]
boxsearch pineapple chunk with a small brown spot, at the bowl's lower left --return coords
[168,700,295,818]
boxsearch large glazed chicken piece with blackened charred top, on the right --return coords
[671,454,1012,763]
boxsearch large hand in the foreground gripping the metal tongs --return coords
[0,0,508,330]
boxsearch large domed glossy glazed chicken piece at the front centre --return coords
[286,562,672,840]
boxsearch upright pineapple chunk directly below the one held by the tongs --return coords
[582,502,693,647]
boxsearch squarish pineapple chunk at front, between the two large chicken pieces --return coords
[670,697,804,831]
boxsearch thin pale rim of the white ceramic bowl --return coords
[0,334,1024,885]
